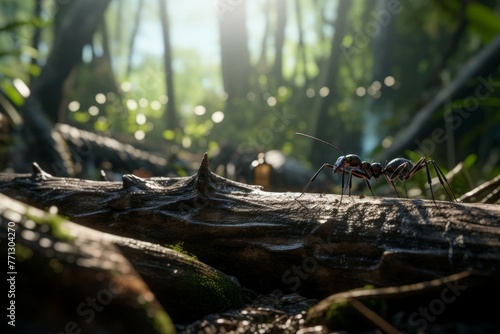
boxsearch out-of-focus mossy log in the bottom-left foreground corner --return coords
[0,195,176,334]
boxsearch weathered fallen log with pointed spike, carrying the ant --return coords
[0,155,500,298]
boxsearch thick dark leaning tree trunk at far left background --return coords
[14,0,110,176]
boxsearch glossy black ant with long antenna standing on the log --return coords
[295,132,457,206]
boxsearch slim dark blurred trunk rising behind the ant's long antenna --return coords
[309,0,351,164]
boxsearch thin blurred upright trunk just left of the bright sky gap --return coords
[158,0,178,129]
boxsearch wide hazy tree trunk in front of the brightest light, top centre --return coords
[218,0,250,110]
